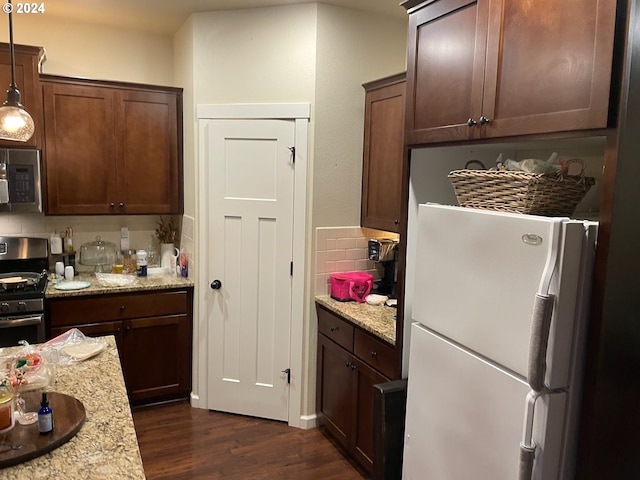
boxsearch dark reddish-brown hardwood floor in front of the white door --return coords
[133,402,367,480]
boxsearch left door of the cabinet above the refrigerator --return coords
[406,0,490,144]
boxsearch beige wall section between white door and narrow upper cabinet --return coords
[313,4,407,228]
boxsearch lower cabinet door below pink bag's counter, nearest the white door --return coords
[316,335,353,448]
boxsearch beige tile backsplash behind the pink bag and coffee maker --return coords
[314,227,399,295]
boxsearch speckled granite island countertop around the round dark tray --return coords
[0,336,146,480]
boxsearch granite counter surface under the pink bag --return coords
[316,295,397,345]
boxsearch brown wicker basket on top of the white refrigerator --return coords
[449,159,595,217]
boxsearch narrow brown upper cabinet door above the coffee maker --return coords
[360,77,406,233]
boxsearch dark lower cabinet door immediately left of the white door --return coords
[122,315,191,404]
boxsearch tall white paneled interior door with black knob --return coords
[201,119,295,420]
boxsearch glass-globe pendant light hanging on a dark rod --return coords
[0,0,35,142]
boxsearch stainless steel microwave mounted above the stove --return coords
[0,148,42,213]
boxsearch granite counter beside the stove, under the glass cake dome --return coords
[45,273,193,298]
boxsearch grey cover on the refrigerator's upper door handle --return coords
[527,293,554,392]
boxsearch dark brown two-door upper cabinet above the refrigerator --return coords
[403,0,616,145]
